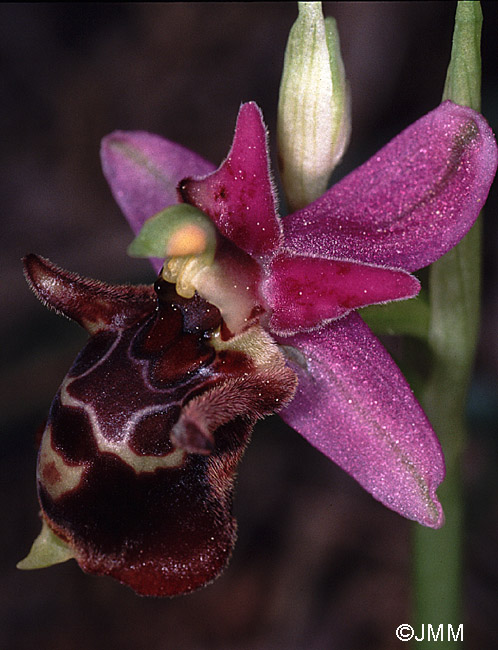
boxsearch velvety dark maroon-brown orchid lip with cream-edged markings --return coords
[20,255,296,596]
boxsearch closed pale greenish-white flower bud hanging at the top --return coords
[277,2,351,211]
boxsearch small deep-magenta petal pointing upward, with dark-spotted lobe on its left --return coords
[181,102,281,255]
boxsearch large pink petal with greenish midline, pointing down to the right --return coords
[280,314,444,528]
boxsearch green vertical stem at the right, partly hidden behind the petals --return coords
[414,1,482,650]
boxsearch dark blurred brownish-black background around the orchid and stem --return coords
[0,2,498,650]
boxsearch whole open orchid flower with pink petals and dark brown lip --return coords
[21,102,497,595]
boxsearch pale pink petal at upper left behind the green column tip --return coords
[101,131,214,234]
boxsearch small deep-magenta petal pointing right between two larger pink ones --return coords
[263,254,420,336]
